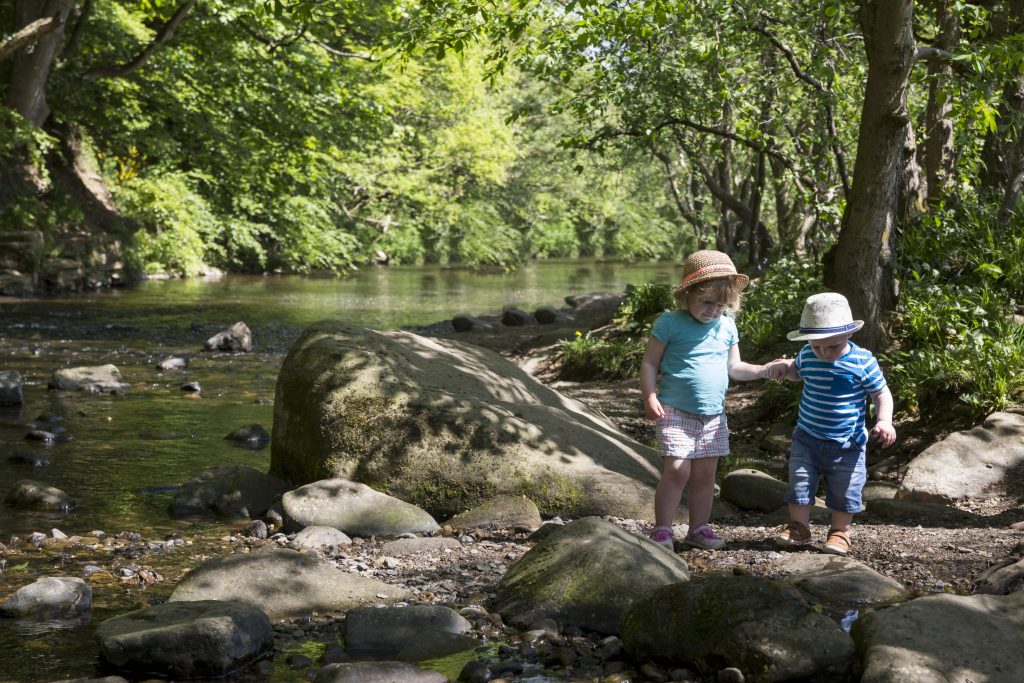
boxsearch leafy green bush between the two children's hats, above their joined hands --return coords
[736,258,824,347]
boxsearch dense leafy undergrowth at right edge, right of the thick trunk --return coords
[887,204,1024,424]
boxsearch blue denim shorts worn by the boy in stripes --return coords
[785,427,867,512]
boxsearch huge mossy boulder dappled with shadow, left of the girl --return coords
[270,321,658,518]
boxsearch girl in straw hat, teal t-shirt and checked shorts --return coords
[640,251,787,550]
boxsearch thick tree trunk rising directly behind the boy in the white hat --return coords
[825,0,916,348]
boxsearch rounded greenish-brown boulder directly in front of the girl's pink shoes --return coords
[495,517,689,634]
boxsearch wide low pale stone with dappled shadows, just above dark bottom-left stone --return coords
[169,548,412,620]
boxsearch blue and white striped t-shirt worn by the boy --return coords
[797,342,886,443]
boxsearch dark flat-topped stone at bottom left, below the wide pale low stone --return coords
[96,600,273,678]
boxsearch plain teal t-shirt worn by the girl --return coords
[650,308,739,415]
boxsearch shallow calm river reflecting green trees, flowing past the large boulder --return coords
[0,260,679,681]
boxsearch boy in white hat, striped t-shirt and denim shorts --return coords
[774,292,896,555]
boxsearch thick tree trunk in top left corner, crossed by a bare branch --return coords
[7,0,75,128]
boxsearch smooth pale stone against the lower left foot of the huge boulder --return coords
[281,479,440,537]
